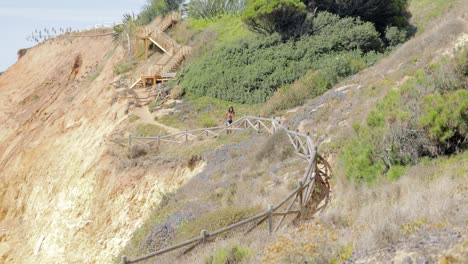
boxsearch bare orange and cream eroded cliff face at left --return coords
[0,32,201,263]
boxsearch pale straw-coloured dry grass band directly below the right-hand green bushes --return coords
[319,153,468,250]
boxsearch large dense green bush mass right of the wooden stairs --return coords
[180,13,382,103]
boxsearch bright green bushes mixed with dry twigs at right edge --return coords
[340,52,468,182]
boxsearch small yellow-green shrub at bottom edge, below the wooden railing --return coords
[205,245,251,264]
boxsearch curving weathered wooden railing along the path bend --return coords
[120,116,330,264]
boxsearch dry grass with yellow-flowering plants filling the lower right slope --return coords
[257,152,468,263]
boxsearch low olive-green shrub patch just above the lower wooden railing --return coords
[177,207,259,241]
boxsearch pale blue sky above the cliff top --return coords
[0,0,146,72]
